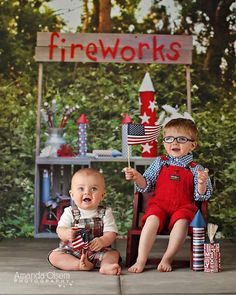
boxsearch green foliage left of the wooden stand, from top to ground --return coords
[0,0,62,237]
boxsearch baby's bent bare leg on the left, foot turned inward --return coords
[48,251,94,270]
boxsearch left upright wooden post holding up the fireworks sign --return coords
[35,63,43,157]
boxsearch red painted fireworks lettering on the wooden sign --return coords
[44,32,189,63]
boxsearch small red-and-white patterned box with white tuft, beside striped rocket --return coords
[204,223,221,272]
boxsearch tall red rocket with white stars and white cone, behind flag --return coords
[139,72,157,157]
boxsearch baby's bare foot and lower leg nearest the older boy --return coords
[99,250,121,276]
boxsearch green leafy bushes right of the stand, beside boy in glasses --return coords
[192,93,236,236]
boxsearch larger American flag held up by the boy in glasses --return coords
[128,123,161,145]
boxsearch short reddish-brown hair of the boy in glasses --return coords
[164,118,198,141]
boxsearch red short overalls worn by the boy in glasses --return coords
[142,157,197,233]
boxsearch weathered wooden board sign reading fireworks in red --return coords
[35,32,193,65]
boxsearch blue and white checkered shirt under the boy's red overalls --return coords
[136,153,212,201]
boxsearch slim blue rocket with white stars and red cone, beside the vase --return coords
[77,114,88,156]
